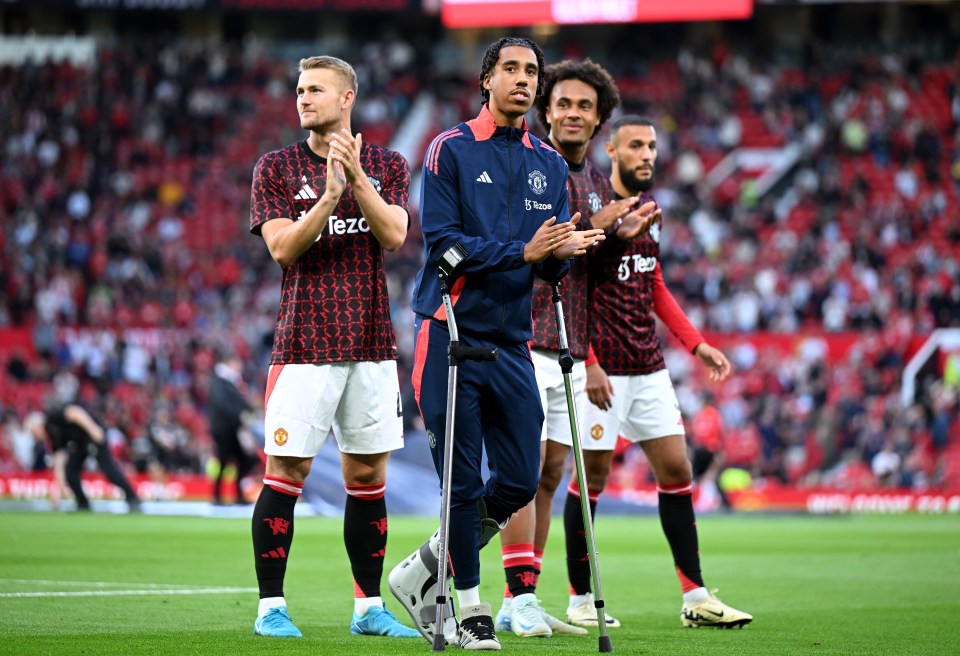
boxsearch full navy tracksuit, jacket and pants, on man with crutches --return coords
[413,106,570,589]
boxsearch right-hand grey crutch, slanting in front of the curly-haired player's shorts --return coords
[552,283,613,653]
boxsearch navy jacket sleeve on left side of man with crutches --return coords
[420,144,528,275]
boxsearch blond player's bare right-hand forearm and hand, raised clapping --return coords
[321,128,410,251]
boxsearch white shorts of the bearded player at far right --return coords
[583,369,686,451]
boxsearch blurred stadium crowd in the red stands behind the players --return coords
[0,20,960,502]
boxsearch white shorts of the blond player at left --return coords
[264,360,403,458]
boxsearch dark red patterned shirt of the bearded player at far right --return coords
[589,193,665,376]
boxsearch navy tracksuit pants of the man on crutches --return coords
[413,317,543,590]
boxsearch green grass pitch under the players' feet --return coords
[0,513,960,656]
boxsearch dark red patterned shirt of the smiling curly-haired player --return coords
[530,159,616,360]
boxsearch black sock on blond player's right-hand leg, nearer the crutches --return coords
[343,485,387,597]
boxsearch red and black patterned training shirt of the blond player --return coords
[250,141,410,364]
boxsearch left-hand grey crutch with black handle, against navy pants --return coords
[433,244,499,651]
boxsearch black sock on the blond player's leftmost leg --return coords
[252,484,302,599]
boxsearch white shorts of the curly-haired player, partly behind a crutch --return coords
[530,351,587,447]
